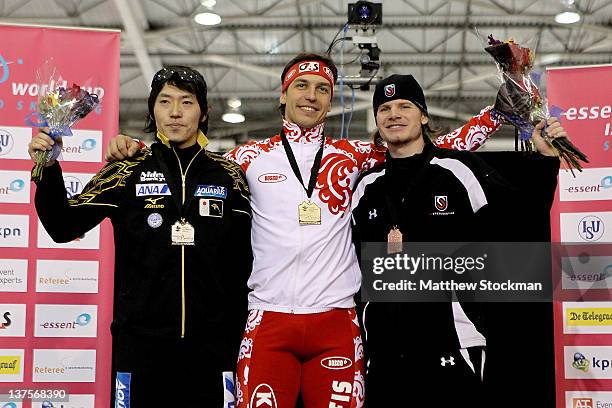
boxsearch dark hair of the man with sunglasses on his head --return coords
[144,65,208,134]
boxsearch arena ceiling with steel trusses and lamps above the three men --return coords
[0,0,612,149]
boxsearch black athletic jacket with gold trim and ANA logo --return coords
[35,142,252,364]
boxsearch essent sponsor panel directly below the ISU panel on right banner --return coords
[561,254,612,289]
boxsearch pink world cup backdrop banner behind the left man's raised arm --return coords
[0,25,120,408]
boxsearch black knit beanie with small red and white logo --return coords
[372,74,427,118]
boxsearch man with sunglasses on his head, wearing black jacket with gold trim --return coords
[29,66,252,408]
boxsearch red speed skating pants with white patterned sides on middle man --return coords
[236,309,364,408]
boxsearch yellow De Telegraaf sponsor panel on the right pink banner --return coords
[563,302,612,334]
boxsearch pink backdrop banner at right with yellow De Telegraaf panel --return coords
[547,65,612,408]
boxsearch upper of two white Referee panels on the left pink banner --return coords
[36,259,100,293]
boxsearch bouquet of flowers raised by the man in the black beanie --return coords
[485,35,589,171]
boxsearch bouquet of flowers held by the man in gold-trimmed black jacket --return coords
[26,63,100,181]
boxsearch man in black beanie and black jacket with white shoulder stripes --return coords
[353,75,566,407]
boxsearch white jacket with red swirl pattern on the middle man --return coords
[226,108,500,313]
